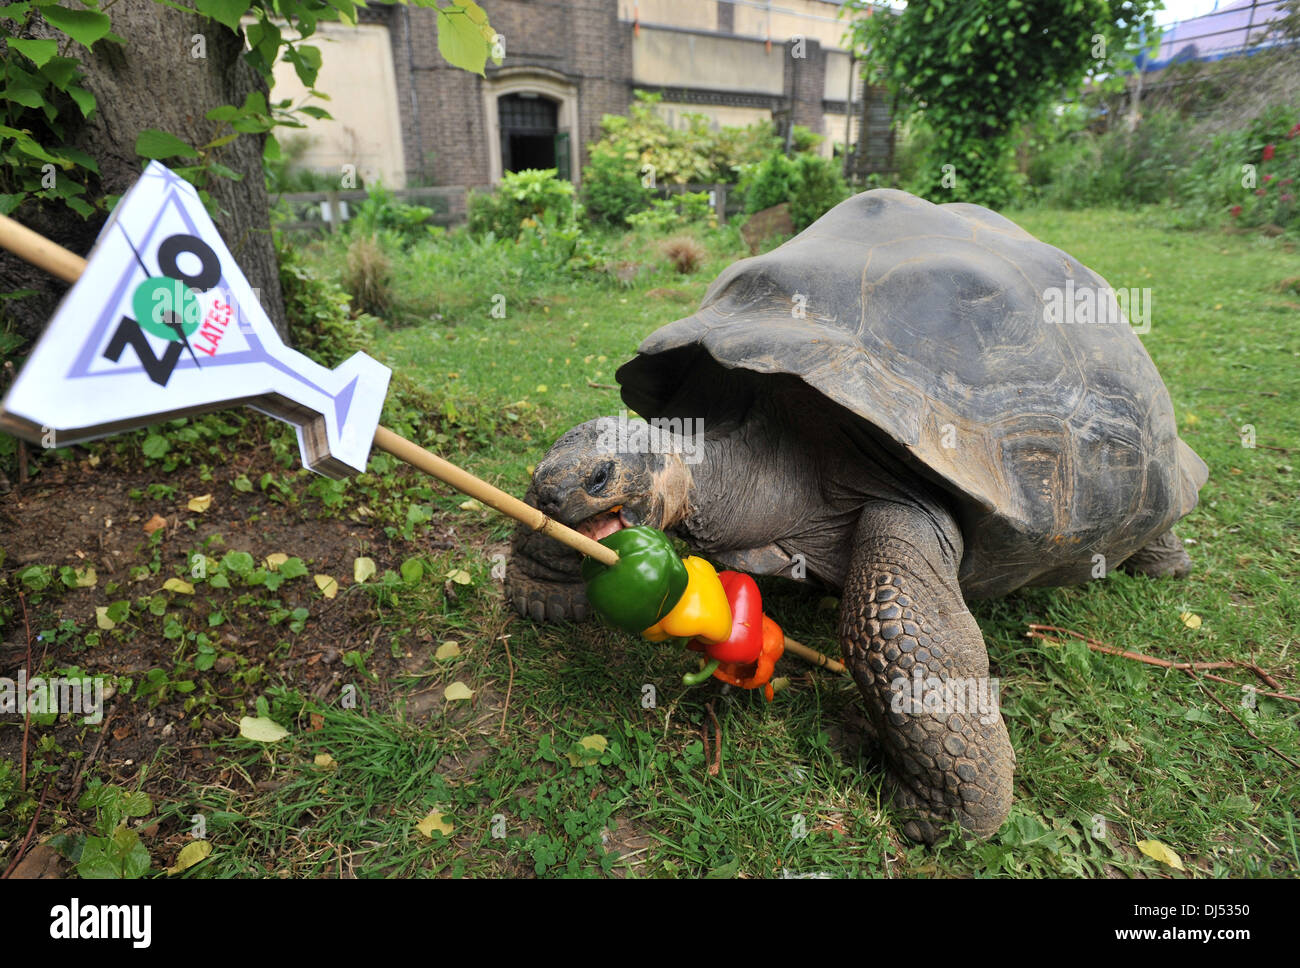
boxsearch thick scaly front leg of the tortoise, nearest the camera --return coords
[840,500,1015,843]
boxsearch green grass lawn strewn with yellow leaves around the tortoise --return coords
[0,203,1300,877]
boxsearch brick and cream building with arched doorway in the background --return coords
[276,0,892,187]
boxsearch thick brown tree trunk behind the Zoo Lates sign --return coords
[0,0,286,339]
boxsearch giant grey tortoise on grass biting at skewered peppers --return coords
[507,190,1208,842]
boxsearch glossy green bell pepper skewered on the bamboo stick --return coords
[582,525,686,633]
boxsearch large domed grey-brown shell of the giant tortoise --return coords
[618,190,1208,598]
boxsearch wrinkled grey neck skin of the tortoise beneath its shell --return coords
[664,395,962,587]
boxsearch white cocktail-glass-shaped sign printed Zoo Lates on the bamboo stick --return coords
[0,161,391,477]
